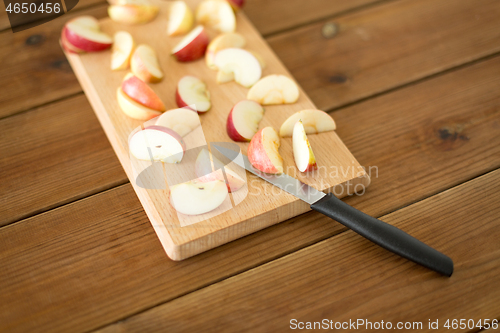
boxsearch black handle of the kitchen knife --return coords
[311,193,453,276]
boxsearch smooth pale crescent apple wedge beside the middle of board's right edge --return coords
[247,74,299,105]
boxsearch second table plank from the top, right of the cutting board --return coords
[268,0,500,110]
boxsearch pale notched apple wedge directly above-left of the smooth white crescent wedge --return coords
[214,48,262,88]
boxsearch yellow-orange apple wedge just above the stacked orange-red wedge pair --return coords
[130,44,163,82]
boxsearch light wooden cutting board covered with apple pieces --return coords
[66,0,370,260]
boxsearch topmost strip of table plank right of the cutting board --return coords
[243,0,383,36]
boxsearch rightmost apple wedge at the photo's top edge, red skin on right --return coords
[196,0,236,32]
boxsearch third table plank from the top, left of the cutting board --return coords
[0,94,127,226]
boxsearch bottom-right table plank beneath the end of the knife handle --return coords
[96,170,500,332]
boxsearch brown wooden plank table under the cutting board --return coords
[0,0,500,332]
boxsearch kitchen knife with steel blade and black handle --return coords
[212,144,453,276]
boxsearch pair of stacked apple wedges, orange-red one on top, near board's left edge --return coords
[117,73,165,120]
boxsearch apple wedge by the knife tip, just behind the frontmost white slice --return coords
[194,149,245,192]
